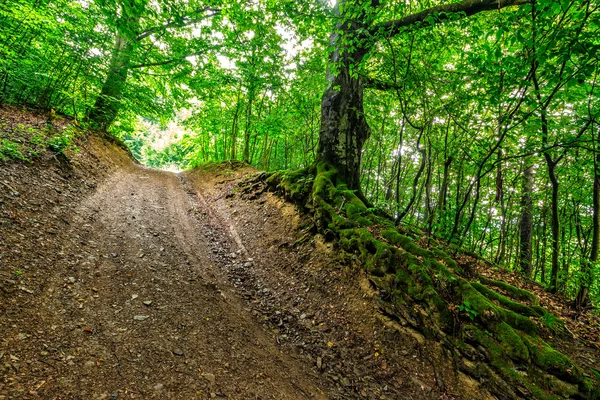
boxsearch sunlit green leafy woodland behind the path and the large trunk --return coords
[0,0,600,307]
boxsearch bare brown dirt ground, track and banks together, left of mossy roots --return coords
[0,117,452,399]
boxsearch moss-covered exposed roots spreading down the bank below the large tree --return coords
[242,163,600,399]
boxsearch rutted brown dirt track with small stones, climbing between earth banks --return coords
[0,166,325,399]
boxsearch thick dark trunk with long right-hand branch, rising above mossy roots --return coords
[317,0,525,198]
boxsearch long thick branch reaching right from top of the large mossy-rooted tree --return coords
[370,0,529,37]
